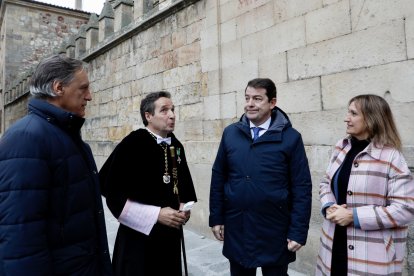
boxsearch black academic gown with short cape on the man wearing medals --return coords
[99,129,196,276]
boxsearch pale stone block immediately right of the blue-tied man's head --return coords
[277,77,322,113]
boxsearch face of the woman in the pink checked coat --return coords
[345,102,369,140]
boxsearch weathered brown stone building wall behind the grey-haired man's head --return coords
[0,0,89,132]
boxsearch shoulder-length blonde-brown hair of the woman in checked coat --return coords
[348,94,401,150]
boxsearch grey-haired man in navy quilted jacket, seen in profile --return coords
[0,55,112,276]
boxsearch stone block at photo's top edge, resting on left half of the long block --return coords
[305,1,351,44]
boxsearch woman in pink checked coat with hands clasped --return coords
[316,95,414,276]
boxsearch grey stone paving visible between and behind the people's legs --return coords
[105,206,305,276]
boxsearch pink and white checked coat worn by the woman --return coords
[316,139,414,275]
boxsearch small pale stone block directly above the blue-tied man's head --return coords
[259,52,287,84]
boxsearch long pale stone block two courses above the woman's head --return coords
[288,20,406,80]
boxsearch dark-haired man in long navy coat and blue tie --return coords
[209,79,312,276]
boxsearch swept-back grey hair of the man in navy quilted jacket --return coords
[29,54,86,98]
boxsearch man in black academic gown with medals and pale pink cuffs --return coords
[99,91,196,276]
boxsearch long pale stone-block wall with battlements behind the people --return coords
[2,0,414,275]
